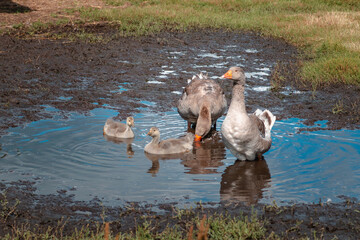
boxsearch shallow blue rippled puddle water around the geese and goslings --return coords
[0,106,360,205]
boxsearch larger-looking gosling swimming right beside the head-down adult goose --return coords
[144,127,194,154]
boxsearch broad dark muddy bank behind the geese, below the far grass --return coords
[0,28,360,137]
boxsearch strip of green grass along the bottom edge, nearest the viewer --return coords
[1,210,270,240]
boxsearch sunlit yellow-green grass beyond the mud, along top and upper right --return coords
[2,0,360,89]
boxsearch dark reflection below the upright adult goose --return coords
[220,159,271,205]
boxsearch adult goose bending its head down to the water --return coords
[177,73,227,141]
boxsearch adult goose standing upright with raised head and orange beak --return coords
[221,67,276,160]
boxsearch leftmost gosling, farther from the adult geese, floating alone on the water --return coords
[104,117,135,138]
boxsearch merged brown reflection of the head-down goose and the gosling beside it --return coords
[145,132,226,176]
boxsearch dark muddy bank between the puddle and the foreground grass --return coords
[0,181,360,239]
